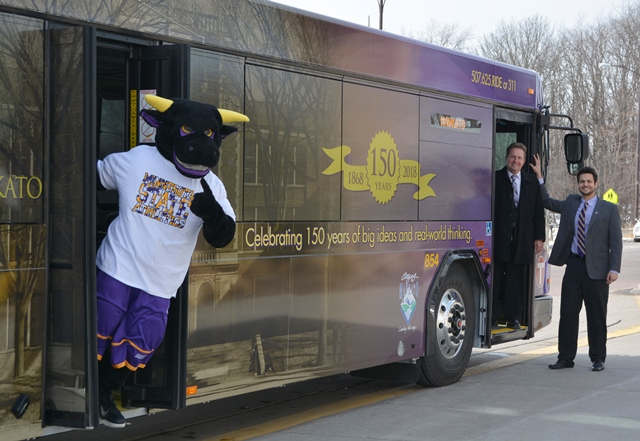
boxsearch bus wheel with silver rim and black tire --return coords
[418,265,475,387]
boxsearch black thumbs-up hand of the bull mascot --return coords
[191,178,236,248]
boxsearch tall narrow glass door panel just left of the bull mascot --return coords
[42,23,98,433]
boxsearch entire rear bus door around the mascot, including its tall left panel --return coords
[42,29,189,433]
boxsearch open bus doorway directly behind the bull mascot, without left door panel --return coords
[96,33,189,409]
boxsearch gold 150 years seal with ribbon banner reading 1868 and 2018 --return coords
[322,131,436,205]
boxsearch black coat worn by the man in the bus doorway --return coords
[493,167,545,265]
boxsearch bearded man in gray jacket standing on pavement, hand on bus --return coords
[531,156,622,371]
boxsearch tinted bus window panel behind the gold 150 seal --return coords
[340,83,419,220]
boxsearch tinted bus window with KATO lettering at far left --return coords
[0,14,44,223]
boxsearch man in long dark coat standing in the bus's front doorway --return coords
[492,142,545,329]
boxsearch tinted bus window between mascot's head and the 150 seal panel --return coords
[242,66,342,221]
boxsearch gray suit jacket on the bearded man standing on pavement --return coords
[540,185,622,279]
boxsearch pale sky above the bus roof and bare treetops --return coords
[275,0,629,44]
